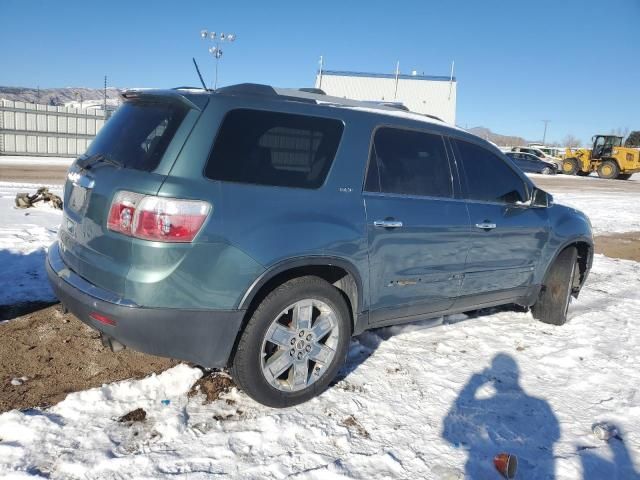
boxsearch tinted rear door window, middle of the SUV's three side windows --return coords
[365,127,453,197]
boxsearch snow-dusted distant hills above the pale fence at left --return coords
[0,87,121,108]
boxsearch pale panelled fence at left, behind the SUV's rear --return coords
[0,99,105,157]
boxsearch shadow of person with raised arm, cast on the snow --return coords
[442,353,560,480]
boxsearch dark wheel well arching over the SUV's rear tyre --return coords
[229,265,360,360]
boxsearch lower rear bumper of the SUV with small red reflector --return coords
[46,242,245,368]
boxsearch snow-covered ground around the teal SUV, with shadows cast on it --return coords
[0,178,640,480]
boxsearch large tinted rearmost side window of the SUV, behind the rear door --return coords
[205,110,343,188]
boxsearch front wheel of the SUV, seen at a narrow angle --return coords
[531,247,578,325]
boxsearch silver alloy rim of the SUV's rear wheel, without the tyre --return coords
[261,299,340,392]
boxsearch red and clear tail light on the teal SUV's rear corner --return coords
[107,191,211,242]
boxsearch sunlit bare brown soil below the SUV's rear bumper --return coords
[0,305,179,412]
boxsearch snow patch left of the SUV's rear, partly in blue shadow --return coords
[0,182,62,305]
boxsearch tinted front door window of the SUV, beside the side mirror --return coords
[452,139,527,203]
